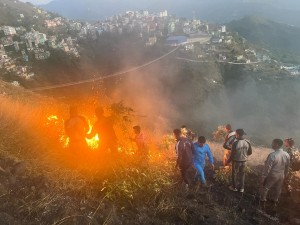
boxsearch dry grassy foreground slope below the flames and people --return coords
[0,82,297,225]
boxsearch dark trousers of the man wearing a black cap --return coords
[232,162,246,189]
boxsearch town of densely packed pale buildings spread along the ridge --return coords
[0,7,300,85]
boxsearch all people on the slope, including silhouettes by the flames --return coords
[65,107,300,216]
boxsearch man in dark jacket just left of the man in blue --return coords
[173,129,195,188]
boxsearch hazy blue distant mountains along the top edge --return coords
[42,0,300,27]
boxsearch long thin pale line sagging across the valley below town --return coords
[30,46,180,92]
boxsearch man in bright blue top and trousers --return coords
[194,136,214,185]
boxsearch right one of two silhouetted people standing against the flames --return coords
[87,107,118,154]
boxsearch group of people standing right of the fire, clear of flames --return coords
[173,124,300,215]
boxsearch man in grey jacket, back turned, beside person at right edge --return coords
[260,139,290,213]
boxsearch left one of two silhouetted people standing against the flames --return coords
[65,106,89,151]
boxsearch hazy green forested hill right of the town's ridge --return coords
[228,16,300,63]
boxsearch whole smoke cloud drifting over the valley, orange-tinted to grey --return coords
[113,56,300,146]
